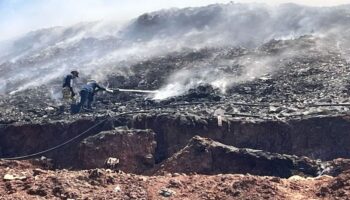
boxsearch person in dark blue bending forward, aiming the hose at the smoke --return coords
[73,80,113,112]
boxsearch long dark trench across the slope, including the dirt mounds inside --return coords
[0,113,350,177]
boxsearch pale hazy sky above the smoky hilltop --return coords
[0,0,350,40]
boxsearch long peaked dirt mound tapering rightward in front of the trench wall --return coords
[156,136,321,178]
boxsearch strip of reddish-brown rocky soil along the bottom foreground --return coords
[0,156,350,200]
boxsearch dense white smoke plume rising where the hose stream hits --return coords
[153,50,284,100]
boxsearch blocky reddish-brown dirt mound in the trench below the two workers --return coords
[78,128,156,173]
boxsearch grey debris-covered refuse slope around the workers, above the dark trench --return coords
[0,36,350,124]
